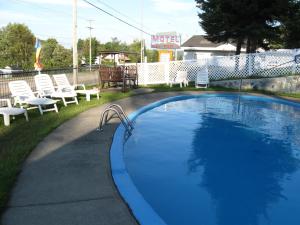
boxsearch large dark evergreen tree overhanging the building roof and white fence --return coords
[196,0,292,54]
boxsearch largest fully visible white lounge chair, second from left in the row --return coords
[8,80,58,115]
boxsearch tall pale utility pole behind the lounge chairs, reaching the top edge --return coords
[73,0,78,85]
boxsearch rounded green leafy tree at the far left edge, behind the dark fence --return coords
[0,23,35,69]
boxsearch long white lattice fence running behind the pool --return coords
[138,49,300,85]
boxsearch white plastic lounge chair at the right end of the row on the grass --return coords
[53,74,100,101]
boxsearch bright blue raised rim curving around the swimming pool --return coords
[110,93,300,225]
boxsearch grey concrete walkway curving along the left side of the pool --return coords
[2,93,183,225]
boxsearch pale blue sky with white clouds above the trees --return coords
[0,0,204,48]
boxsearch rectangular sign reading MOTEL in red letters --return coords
[151,33,180,49]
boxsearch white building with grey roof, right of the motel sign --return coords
[181,35,246,60]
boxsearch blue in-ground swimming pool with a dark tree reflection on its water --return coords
[111,94,300,225]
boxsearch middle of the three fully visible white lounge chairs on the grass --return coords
[34,74,78,106]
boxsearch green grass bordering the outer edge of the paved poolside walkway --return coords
[0,85,300,212]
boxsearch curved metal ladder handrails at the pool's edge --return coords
[97,104,133,134]
